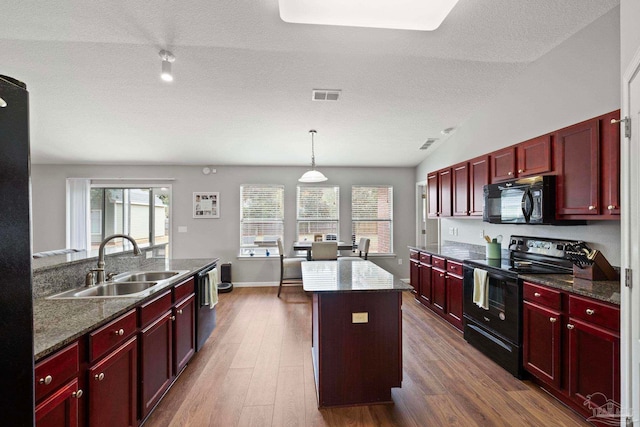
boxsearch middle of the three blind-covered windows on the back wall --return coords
[297,186,340,242]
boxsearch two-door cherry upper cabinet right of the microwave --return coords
[554,110,620,219]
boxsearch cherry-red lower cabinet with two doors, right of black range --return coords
[523,282,620,417]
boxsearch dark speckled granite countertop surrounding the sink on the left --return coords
[33,258,218,361]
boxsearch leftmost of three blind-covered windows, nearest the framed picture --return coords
[240,184,284,256]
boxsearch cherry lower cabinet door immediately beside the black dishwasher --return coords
[173,294,196,375]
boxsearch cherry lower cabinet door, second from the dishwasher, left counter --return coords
[140,311,173,419]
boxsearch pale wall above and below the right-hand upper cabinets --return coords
[416,7,620,265]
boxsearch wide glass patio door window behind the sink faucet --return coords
[89,185,169,251]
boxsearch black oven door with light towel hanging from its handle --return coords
[463,265,521,344]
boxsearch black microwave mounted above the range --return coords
[483,175,566,224]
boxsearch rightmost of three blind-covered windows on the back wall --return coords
[351,185,393,253]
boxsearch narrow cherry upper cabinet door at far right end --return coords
[601,110,620,219]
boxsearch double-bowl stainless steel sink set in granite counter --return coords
[47,270,189,299]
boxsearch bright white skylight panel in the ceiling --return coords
[278,0,458,31]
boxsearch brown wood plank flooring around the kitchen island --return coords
[144,286,590,427]
